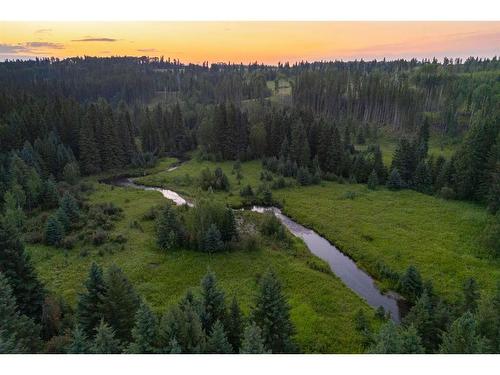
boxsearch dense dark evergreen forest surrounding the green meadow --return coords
[0,57,500,353]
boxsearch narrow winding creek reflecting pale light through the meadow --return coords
[101,177,407,322]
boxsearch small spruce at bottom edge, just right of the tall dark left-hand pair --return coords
[128,303,158,354]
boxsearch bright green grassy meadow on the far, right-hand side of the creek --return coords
[140,160,500,300]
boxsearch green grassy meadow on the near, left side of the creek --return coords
[27,172,373,353]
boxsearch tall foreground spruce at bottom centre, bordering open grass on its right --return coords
[252,271,295,353]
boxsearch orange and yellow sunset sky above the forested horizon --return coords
[0,21,500,64]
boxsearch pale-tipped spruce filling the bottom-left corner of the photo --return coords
[0,272,39,354]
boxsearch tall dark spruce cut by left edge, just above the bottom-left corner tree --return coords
[0,216,44,322]
